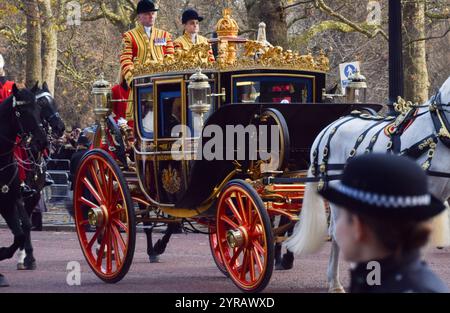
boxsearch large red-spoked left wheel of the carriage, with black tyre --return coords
[73,149,136,283]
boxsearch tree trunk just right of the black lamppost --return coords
[403,0,430,103]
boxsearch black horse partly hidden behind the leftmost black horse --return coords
[17,82,65,270]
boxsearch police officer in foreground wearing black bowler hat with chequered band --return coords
[320,154,449,293]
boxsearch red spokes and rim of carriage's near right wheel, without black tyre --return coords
[217,185,268,291]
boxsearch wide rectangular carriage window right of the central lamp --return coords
[233,76,314,103]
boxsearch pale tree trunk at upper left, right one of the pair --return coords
[39,0,58,94]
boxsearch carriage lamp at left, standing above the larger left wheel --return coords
[92,74,112,145]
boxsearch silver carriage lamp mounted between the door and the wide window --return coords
[188,68,211,134]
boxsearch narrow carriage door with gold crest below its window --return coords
[154,77,187,204]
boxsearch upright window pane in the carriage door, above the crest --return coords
[158,84,182,138]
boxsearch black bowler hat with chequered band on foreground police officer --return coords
[319,153,445,221]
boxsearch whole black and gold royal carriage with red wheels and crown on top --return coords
[74,12,379,292]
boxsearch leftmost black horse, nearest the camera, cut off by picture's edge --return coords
[0,85,48,284]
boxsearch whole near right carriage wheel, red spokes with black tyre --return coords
[216,180,274,292]
